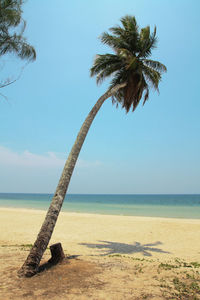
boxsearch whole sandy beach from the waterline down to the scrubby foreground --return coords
[0,208,200,299]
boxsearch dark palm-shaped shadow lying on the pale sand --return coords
[80,241,170,256]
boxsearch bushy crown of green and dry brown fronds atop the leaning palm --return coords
[90,16,167,112]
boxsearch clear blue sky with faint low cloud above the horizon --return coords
[0,0,200,194]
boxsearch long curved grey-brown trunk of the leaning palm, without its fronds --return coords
[18,83,126,277]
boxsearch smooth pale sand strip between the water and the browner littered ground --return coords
[0,208,200,262]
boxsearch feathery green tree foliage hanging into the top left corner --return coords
[0,0,36,88]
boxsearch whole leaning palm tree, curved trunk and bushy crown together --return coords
[19,16,166,276]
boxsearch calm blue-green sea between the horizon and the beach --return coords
[0,193,200,219]
